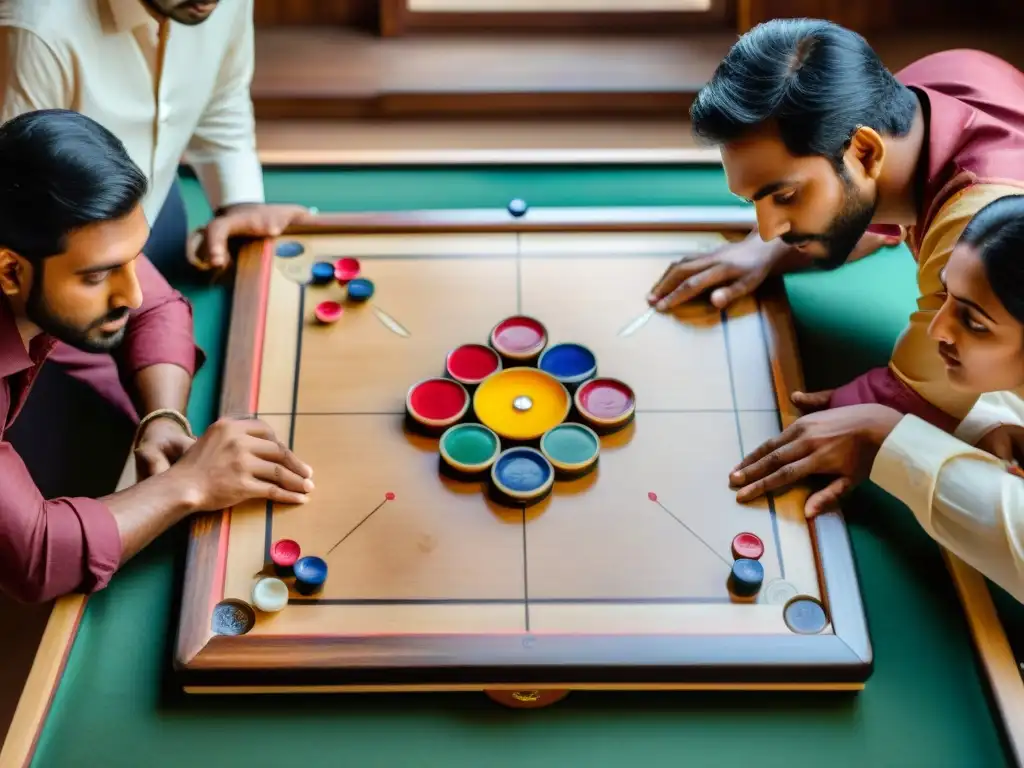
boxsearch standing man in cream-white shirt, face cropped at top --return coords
[0,0,305,273]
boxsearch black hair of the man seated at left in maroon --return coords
[0,110,148,262]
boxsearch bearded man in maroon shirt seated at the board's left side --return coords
[0,111,312,601]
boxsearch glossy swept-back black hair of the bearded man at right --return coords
[690,18,918,165]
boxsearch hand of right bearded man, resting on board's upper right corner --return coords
[647,234,780,311]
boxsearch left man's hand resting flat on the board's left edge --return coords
[167,419,313,511]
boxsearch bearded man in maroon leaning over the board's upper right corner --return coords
[650,18,1024,430]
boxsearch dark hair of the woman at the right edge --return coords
[959,195,1024,323]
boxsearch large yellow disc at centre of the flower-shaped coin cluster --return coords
[473,368,572,440]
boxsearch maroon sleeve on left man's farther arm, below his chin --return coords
[115,256,205,388]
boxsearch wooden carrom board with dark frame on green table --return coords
[176,208,871,702]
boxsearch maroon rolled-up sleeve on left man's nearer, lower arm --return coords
[0,442,122,602]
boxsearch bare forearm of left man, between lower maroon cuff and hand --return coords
[99,471,196,564]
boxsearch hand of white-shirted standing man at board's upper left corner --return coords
[187,203,312,270]
